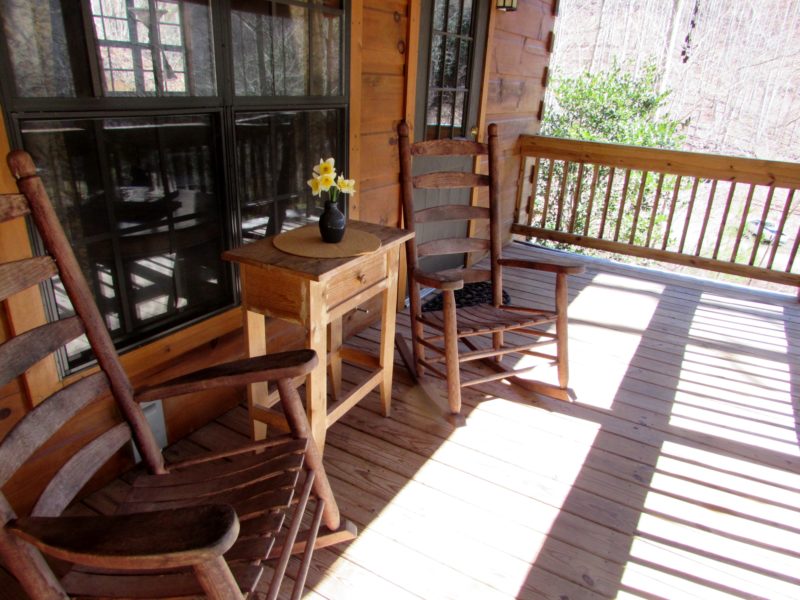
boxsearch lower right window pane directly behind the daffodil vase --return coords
[236,109,344,240]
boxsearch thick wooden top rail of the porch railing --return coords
[520,135,800,188]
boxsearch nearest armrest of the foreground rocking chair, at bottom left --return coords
[6,504,239,569]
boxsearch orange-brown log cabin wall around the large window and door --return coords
[0,0,556,506]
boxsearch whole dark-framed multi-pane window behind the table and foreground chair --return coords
[0,0,347,370]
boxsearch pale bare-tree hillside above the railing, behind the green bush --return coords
[547,0,800,162]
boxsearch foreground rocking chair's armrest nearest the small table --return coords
[135,350,318,402]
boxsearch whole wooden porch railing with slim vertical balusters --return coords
[512,136,800,296]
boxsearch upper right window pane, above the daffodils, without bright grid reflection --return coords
[231,0,343,96]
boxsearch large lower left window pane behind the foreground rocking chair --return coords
[21,116,232,364]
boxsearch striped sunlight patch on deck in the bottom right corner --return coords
[619,442,800,599]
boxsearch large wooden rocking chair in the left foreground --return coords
[0,152,355,600]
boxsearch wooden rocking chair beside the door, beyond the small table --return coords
[398,123,583,414]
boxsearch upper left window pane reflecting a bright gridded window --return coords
[0,0,217,98]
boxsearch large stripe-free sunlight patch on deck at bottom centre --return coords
[315,398,599,599]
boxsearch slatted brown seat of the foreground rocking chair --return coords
[52,438,307,598]
